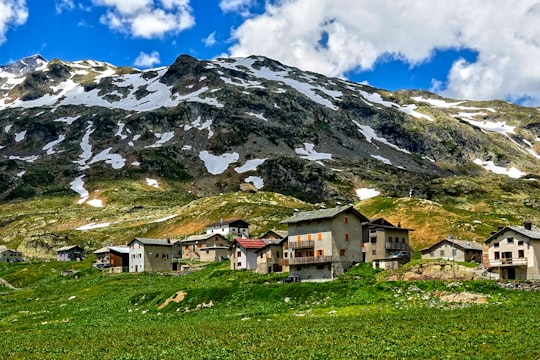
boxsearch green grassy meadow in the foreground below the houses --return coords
[0,261,540,359]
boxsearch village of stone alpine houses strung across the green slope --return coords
[0,205,540,282]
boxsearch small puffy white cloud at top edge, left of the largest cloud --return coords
[92,0,195,39]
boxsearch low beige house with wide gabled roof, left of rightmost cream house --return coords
[420,237,482,262]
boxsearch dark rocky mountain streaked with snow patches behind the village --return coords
[0,55,540,256]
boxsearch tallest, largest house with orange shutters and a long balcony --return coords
[282,205,369,279]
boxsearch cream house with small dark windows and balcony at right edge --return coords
[483,222,540,280]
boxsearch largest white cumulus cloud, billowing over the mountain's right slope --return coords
[227,0,540,103]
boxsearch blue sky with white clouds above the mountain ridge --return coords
[0,0,540,106]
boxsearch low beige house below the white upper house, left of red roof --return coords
[176,234,229,262]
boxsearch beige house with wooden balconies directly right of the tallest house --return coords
[362,218,412,262]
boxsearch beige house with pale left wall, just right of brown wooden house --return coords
[128,238,173,272]
